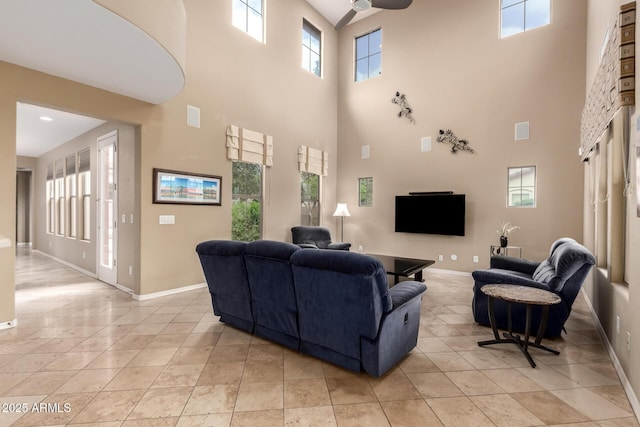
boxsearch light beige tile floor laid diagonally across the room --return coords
[0,250,639,427]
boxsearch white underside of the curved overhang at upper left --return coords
[0,0,186,104]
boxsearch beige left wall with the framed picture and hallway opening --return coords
[0,0,337,321]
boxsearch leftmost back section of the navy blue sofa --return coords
[196,240,253,321]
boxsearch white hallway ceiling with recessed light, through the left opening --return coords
[16,102,105,157]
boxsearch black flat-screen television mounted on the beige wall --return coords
[396,192,465,236]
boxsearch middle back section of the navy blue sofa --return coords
[244,240,302,337]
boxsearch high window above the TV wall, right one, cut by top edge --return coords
[500,0,551,38]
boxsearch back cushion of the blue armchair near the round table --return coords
[532,241,595,293]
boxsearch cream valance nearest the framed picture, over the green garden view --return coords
[226,125,273,166]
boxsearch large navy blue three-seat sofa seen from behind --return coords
[196,240,426,377]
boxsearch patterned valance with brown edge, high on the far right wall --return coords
[580,2,636,160]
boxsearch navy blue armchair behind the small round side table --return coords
[472,238,595,337]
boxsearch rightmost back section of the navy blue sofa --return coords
[291,249,392,359]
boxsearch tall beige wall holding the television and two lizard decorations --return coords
[338,0,587,271]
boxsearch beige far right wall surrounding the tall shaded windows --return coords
[584,0,640,411]
